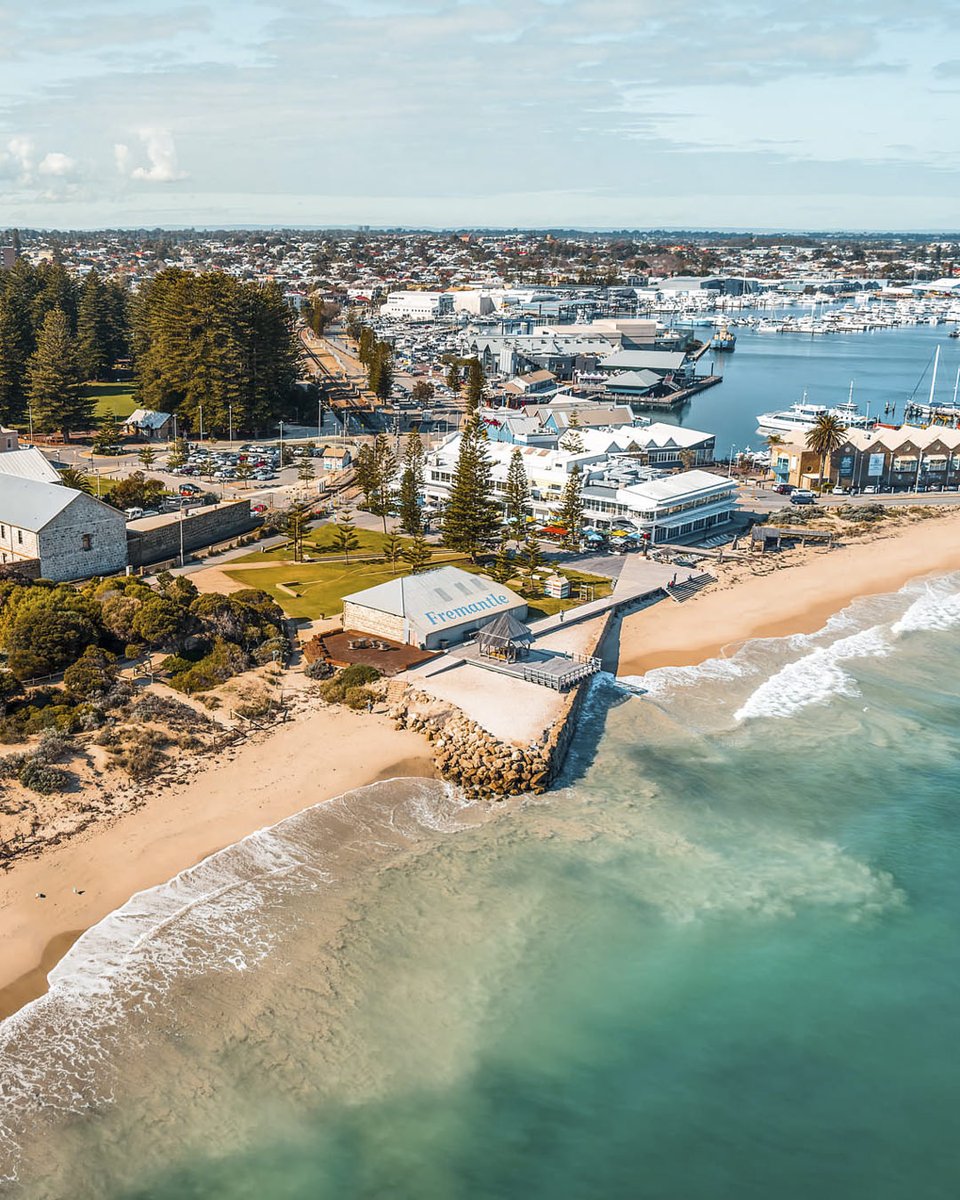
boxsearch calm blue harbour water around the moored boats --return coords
[672,325,960,458]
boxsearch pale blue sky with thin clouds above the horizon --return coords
[0,0,960,230]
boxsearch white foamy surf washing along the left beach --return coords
[0,780,467,1186]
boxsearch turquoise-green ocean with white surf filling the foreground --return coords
[0,575,960,1200]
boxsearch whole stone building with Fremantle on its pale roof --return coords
[343,566,527,650]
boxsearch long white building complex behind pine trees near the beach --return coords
[424,430,737,541]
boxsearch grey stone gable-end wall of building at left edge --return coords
[35,493,127,582]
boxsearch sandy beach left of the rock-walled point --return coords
[0,707,434,1018]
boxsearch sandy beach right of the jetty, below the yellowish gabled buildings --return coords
[617,512,960,676]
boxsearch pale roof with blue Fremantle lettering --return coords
[343,566,527,630]
